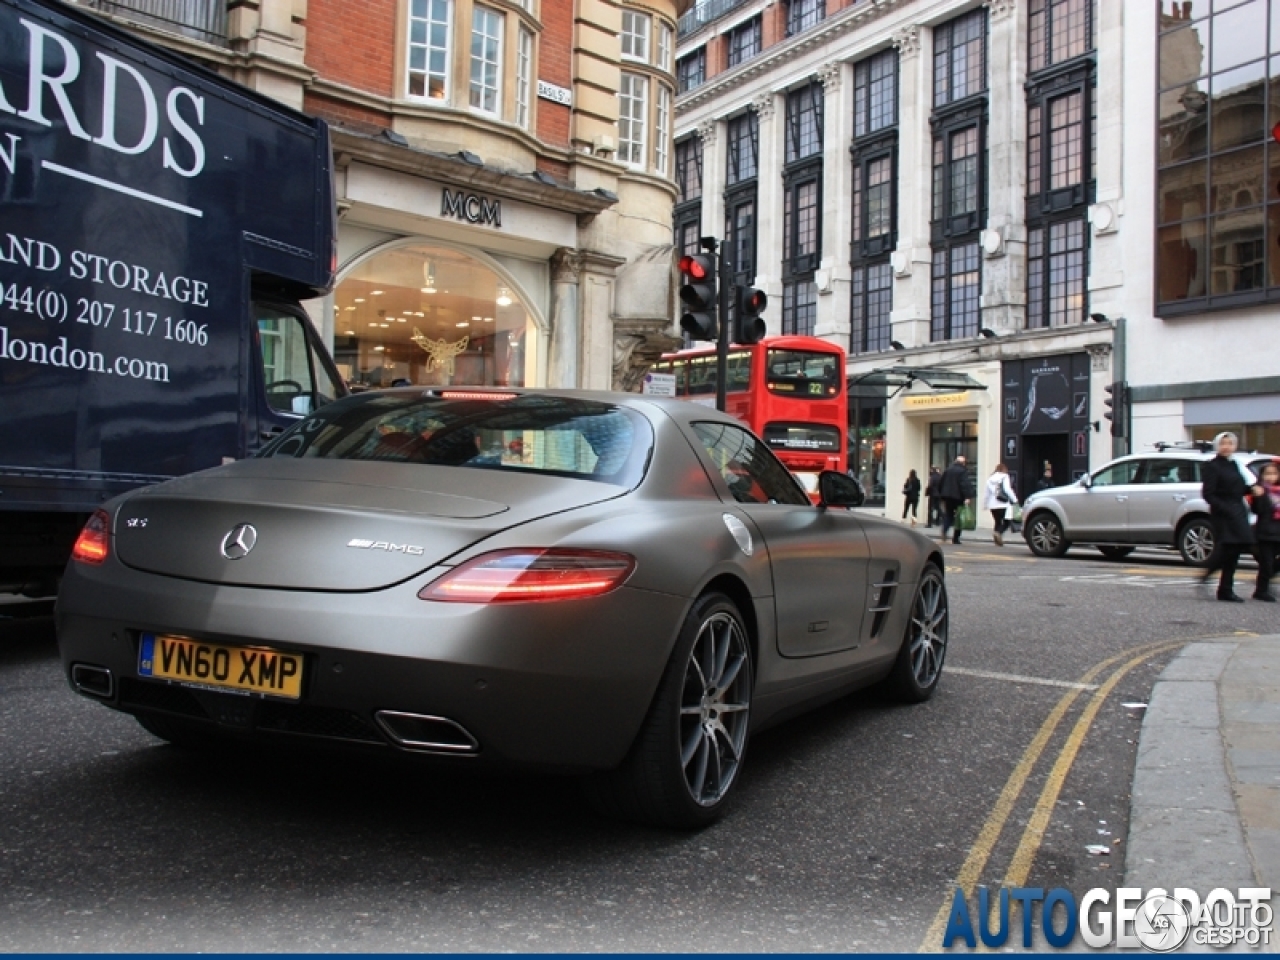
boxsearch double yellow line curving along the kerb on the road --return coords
[920,637,1193,952]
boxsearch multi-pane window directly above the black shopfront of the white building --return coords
[1027,218,1088,329]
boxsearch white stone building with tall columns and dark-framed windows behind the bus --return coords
[675,0,1116,504]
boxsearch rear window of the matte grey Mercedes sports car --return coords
[257,390,653,488]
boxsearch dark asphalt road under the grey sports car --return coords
[0,544,1280,951]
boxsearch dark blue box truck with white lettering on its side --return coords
[0,0,346,595]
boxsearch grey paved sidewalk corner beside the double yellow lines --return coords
[1125,635,1280,890]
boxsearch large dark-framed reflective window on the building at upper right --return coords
[1156,0,1280,316]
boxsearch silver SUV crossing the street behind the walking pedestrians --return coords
[1023,444,1274,566]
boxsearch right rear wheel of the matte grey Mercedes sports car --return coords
[586,593,754,829]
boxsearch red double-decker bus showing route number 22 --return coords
[654,337,849,495]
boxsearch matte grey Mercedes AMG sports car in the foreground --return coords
[58,388,948,826]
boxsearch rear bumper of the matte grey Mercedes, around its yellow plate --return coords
[58,561,687,769]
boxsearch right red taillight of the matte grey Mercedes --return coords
[417,549,636,603]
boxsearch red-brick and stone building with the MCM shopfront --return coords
[72,0,680,389]
